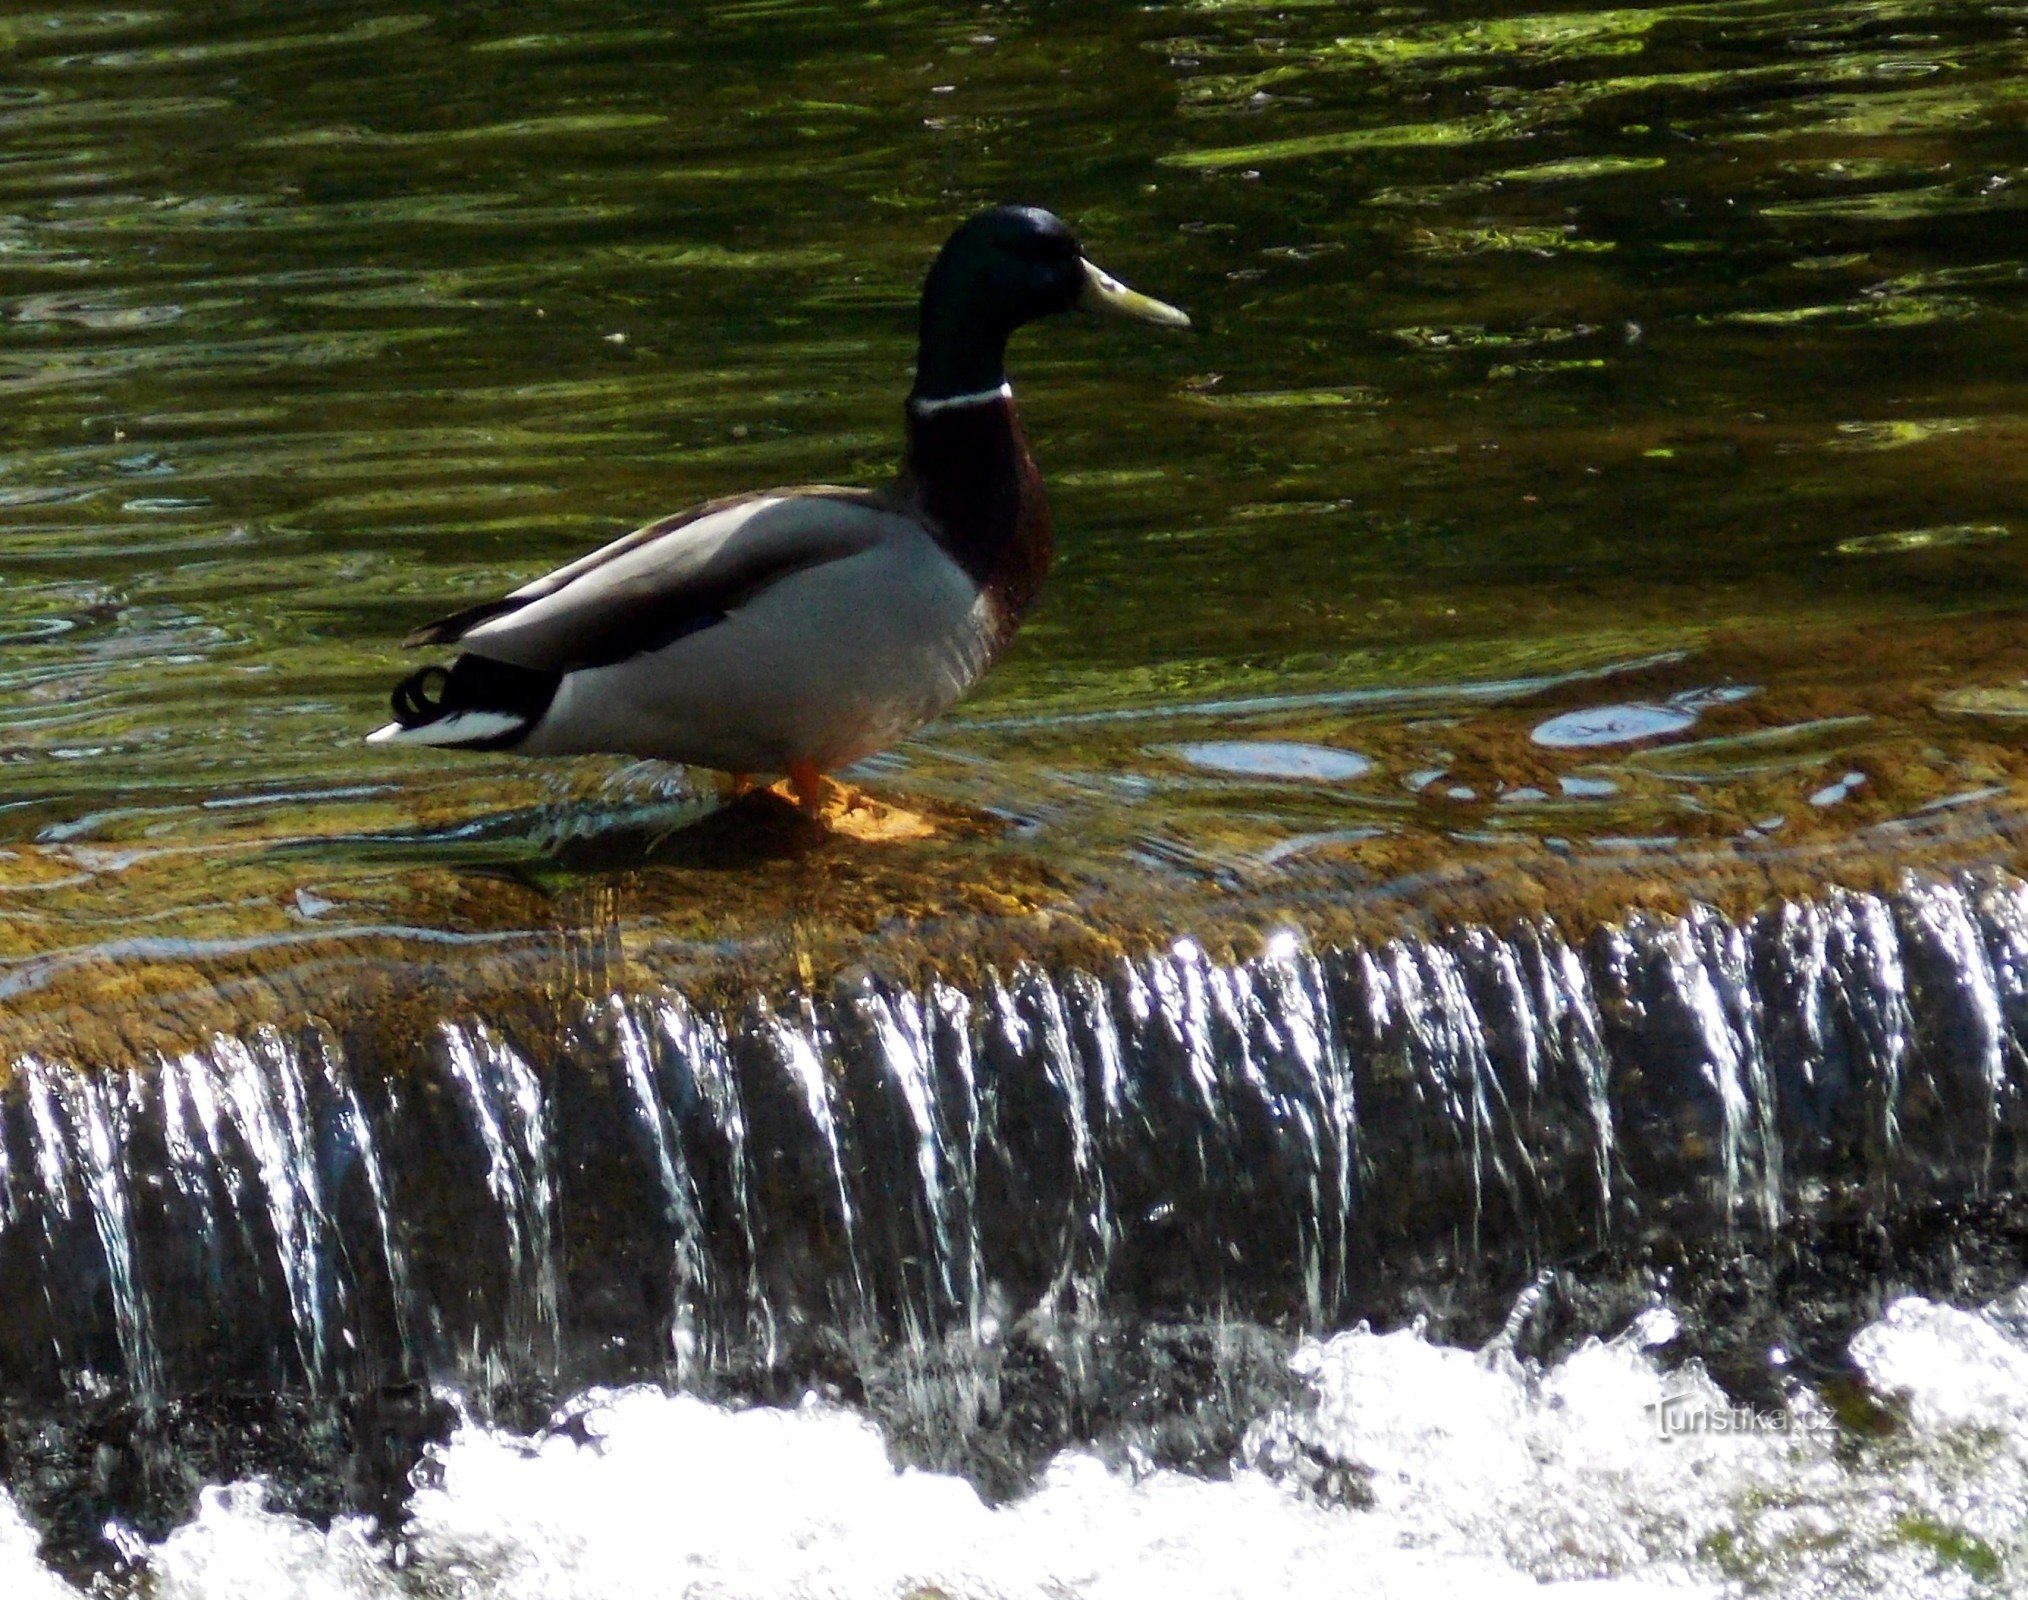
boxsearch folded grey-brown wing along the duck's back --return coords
[404,485,915,671]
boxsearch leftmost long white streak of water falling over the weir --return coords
[16,1059,162,1399]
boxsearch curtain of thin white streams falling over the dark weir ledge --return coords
[0,874,2028,1399]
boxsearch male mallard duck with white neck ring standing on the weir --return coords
[367,205,1190,811]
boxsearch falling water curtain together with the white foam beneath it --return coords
[0,876,2028,1596]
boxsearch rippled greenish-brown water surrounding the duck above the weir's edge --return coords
[0,0,2028,992]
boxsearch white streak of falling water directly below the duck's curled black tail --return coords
[440,1024,562,1371]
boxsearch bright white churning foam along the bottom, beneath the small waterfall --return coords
[19,1296,2028,1600]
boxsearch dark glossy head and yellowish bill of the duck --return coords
[913,205,1190,399]
